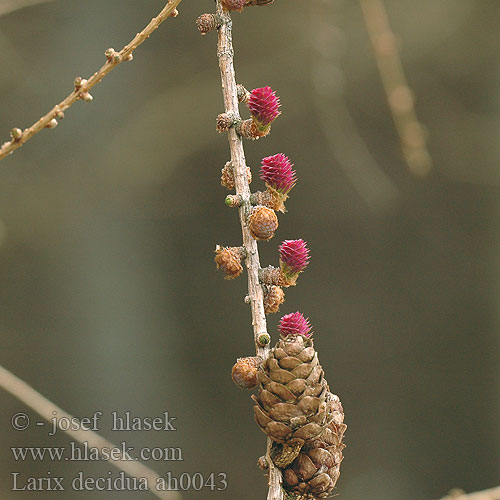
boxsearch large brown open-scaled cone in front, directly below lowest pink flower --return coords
[252,335,331,468]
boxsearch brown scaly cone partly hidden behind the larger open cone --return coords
[282,393,347,500]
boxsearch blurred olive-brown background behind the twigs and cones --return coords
[0,0,500,500]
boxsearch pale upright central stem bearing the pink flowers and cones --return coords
[217,0,283,500]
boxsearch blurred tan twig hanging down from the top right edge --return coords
[360,0,432,175]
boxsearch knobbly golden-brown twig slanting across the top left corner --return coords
[0,0,182,160]
